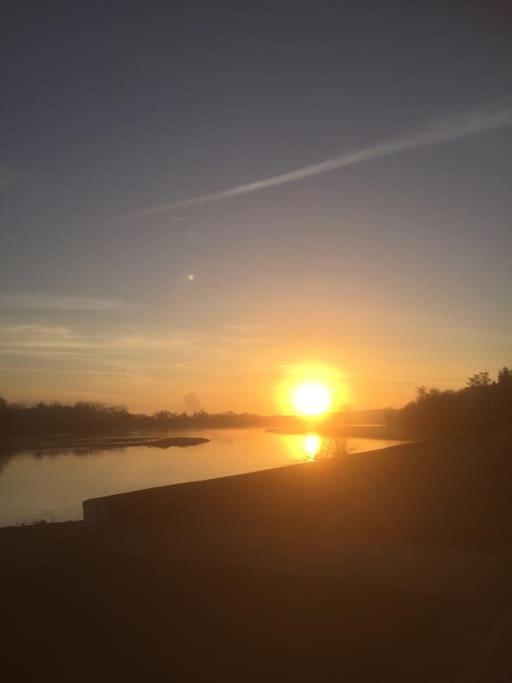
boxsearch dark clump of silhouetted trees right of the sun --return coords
[387,367,512,437]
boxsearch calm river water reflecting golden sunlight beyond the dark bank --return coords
[0,429,406,526]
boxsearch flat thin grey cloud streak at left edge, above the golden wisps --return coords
[0,293,133,311]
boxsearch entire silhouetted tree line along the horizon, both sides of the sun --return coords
[0,367,512,438]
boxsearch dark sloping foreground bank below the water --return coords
[0,434,512,683]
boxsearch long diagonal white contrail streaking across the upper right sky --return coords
[144,109,512,215]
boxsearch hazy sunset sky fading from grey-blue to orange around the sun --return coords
[0,0,512,414]
